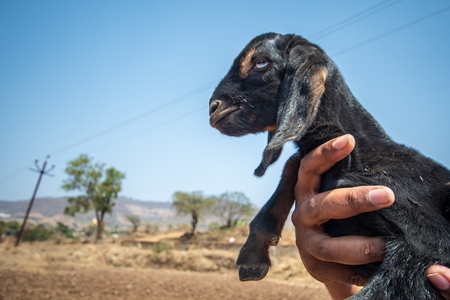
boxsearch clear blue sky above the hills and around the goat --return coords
[0,0,450,205]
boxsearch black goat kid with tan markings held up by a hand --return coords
[209,33,450,300]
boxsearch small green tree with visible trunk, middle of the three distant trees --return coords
[172,191,212,235]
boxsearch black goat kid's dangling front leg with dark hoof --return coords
[237,153,300,281]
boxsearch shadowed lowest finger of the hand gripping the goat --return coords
[301,253,367,286]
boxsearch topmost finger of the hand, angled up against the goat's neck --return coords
[295,134,355,201]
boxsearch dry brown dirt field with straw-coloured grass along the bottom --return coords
[0,232,330,300]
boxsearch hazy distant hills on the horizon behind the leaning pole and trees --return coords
[0,198,189,228]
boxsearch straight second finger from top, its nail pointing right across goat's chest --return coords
[298,186,395,227]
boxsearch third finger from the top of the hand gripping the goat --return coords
[297,229,385,265]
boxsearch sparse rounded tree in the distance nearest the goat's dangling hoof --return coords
[212,192,253,228]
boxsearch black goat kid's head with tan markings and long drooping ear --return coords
[209,33,330,176]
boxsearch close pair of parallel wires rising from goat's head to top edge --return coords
[308,0,402,41]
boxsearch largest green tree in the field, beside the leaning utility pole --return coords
[62,154,125,242]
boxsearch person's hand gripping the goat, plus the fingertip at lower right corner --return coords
[292,135,450,300]
